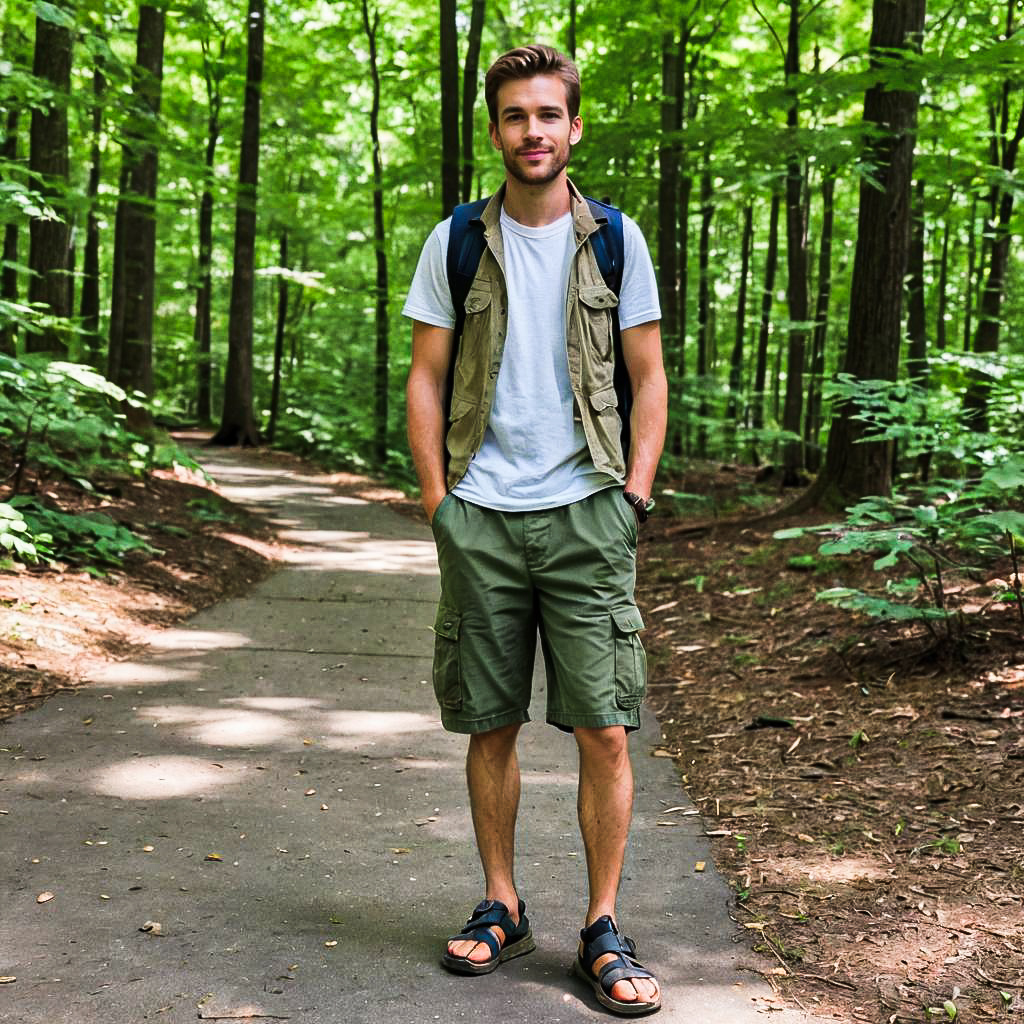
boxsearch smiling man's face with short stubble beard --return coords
[489,75,583,185]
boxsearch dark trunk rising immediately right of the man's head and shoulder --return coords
[657,32,679,382]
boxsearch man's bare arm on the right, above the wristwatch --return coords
[623,321,669,499]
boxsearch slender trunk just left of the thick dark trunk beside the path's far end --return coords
[193,35,225,425]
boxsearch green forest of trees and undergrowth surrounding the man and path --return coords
[0,0,1024,1022]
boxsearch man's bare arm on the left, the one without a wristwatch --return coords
[406,321,455,519]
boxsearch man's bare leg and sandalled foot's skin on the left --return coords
[449,723,520,963]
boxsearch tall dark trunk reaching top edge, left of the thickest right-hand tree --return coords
[782,0,808,487]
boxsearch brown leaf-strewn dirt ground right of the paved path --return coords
[638,471,1024,1024]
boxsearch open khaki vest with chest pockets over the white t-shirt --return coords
[445,182,626,489]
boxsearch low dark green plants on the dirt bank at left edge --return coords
[9,495,160,575]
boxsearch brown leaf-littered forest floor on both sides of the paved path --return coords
[0,451,1024,1024]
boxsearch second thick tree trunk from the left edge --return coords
[109,4,166,429]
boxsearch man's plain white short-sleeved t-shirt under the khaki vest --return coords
[402,201,662,512]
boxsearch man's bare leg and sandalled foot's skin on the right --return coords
[574,725,658,1002]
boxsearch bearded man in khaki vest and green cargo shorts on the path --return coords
[403,45,668,1015]
